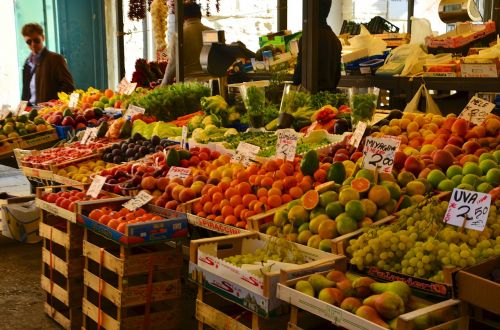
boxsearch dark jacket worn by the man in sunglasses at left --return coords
[22,48,75,103]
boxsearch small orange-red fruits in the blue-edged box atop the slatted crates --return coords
[88,206,165,234]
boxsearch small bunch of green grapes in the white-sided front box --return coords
[224,237,304,267]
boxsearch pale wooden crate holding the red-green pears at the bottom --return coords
[277,270,469,330]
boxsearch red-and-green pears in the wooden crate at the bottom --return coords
[295,270,455,329]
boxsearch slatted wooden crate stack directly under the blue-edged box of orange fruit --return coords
[82,229,182,329]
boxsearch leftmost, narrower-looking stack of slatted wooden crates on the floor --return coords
[40,210,83,329]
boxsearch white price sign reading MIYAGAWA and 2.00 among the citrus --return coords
[363,137,401,173]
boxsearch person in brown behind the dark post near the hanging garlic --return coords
[161,2,210,86]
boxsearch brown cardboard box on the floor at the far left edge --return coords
[0,195,41,244]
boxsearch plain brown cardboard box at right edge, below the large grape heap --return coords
[455,257,500,314]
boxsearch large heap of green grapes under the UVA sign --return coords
[347,198,500,282]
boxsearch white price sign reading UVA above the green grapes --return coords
[444,188,491,231]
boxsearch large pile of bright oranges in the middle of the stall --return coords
[191,158,330,229]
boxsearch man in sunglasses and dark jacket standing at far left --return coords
[21,23,75,105]
